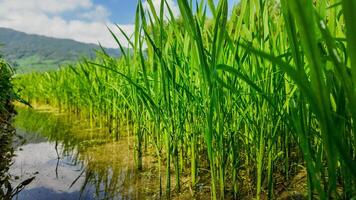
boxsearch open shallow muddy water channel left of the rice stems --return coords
[10,108,159,200]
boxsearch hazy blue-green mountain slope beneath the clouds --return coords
[0,27,120,73]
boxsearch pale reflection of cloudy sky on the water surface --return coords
[11,142,94,200]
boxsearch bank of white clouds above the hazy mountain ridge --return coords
[0,0,134,47]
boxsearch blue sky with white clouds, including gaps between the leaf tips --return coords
[0,0,238,48]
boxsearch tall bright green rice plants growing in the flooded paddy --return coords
[16,0,356,199]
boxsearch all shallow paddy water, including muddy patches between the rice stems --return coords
[12,106,314,199]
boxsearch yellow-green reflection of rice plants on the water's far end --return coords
[14,107,108,155]
